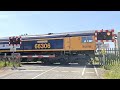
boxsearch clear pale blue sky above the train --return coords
[0,11,120,45]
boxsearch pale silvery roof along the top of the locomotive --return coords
[0,30,95,41]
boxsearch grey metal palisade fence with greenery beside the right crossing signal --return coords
[93,48,120,66]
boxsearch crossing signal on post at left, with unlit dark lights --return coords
[9,37,21,67]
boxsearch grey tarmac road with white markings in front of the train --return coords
[0,64,104,79]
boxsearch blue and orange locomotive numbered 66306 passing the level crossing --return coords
[0,30,96,64]
